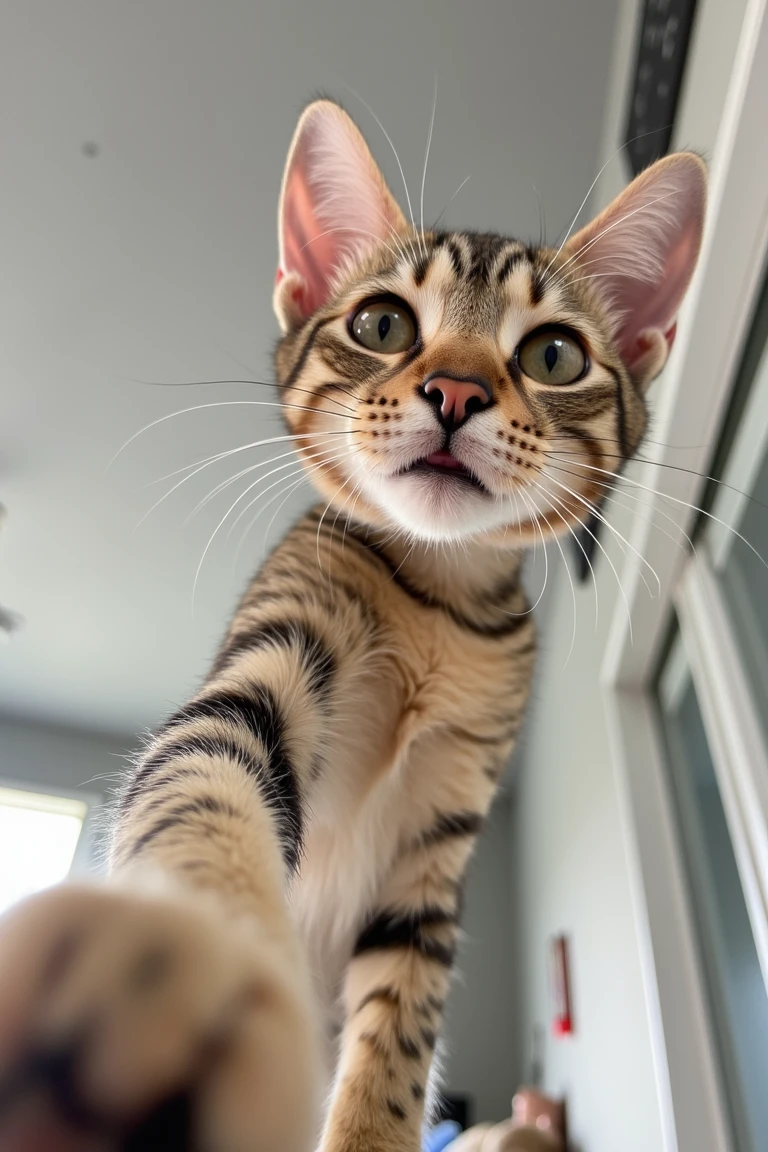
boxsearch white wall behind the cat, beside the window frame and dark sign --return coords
[511,0,744,1152]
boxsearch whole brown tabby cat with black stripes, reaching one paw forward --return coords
[0,100,706,1152]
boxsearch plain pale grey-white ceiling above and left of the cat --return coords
[0,0,615,732]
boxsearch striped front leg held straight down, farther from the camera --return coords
[321,816,480,1152]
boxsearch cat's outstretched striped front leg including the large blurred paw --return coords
[0,622,329,1152]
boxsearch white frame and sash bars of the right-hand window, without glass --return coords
[601,0,768,1152]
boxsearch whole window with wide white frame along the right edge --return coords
[602,11,768,1152]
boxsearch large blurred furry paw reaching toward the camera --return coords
[0,886,315,1152]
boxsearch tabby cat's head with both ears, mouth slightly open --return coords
[274,100,706,544]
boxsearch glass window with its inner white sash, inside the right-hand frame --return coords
[657,263,768,1152]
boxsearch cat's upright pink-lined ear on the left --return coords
[274,100,405,332]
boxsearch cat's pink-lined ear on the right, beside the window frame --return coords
[563,152,707,388]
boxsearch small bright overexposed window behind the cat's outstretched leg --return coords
[0,788,88,914]
